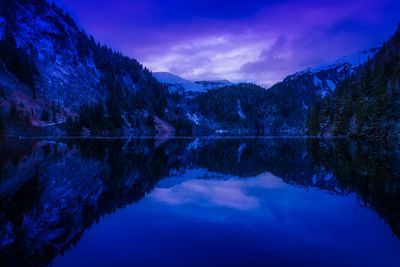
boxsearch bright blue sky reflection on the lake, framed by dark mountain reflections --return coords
[54,173,400,266]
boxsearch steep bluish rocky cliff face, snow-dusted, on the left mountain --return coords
[6,1,104,108]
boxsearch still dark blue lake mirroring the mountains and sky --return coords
[0,138,400,266]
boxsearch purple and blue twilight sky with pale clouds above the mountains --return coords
[55,0,400,86]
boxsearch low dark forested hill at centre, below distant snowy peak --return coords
[186,83,278,134]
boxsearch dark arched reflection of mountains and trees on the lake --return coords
[0,138,400,266]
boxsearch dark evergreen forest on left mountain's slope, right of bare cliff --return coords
[51,3,177,135]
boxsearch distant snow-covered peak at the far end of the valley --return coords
[153,72,233,97]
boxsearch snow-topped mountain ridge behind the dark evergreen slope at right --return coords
[268,48,378,135]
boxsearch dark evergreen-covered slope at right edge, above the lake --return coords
[308,25,400,139]
